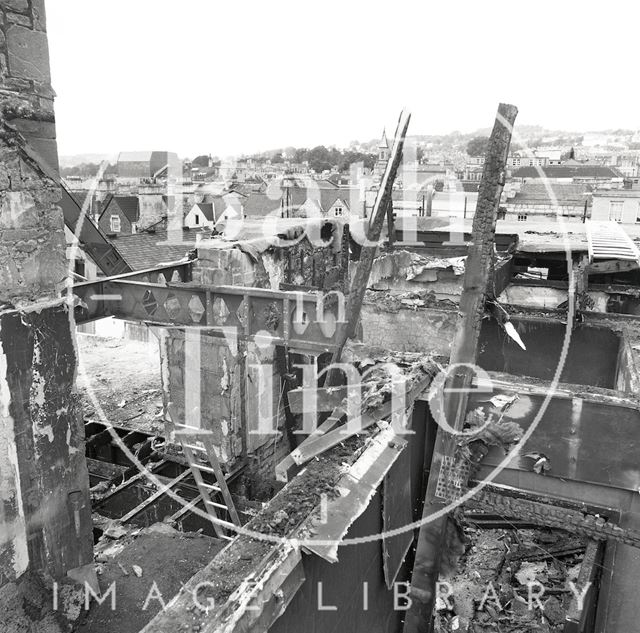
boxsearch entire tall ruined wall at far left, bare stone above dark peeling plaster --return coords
[0,0,93,604]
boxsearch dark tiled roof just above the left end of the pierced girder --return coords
[112,220,206,270]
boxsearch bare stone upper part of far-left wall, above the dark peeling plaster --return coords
[0,0,67,305]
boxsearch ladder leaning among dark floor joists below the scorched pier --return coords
[173,422,241,541]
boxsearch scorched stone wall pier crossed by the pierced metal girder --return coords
[161,240,291,477]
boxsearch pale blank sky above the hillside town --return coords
[45,0,640,158]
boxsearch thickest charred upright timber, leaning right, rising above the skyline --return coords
[404,103,518,633]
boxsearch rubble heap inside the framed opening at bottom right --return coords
[435,527,586,633]
